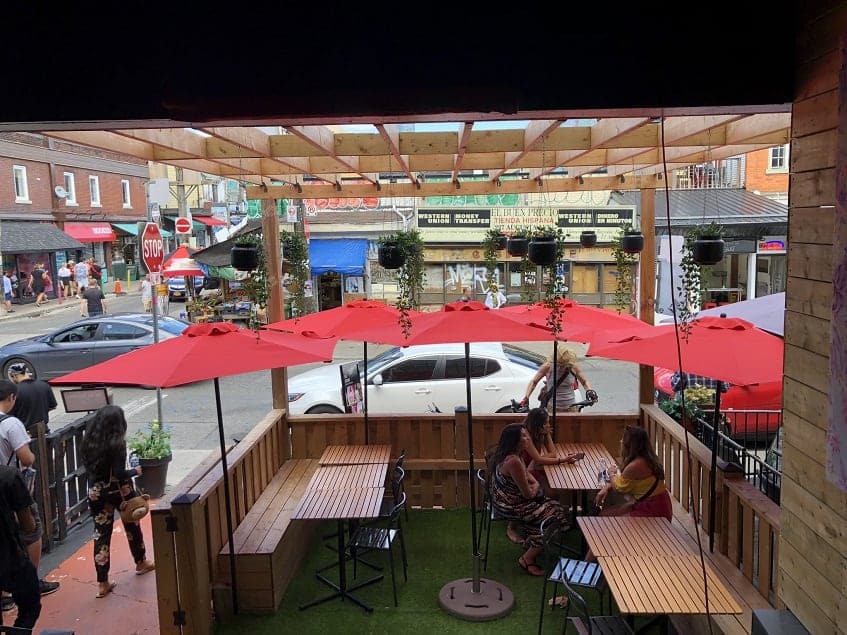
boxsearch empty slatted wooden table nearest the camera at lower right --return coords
[577,516,742,616]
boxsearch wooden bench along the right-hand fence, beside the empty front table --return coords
[671,498,773,635]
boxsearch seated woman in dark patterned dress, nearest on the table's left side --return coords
[488,423,568,576]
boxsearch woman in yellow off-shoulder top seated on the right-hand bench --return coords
[594,426,673,522]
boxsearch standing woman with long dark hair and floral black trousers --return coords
[82,405,156,598]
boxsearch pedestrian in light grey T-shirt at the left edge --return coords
[0,379,59,595]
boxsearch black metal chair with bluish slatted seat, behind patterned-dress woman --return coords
[538,518,612,634]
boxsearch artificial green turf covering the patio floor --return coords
[215,509,598,635]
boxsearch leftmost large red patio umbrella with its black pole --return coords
[50,322,335,613]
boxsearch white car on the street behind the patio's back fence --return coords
[288,343,556,414]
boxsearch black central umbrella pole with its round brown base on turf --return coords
[438,342,515,622]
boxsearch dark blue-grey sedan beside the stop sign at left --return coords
[0,313,188,380]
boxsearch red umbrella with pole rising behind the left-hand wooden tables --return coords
[265,300,419,444]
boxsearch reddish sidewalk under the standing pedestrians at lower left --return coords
[3,516,159,635]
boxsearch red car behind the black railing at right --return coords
[653,368,782,444]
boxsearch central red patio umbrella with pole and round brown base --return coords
[348,301,554,616]
